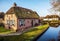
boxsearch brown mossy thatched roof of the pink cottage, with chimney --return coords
[6,3,39,18]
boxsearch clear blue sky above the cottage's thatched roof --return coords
[0,0,51,16]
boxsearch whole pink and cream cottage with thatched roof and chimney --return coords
[4,3,39,30]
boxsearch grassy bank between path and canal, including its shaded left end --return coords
[0,24,49,41]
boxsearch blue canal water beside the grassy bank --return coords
[37,26,60,41]
